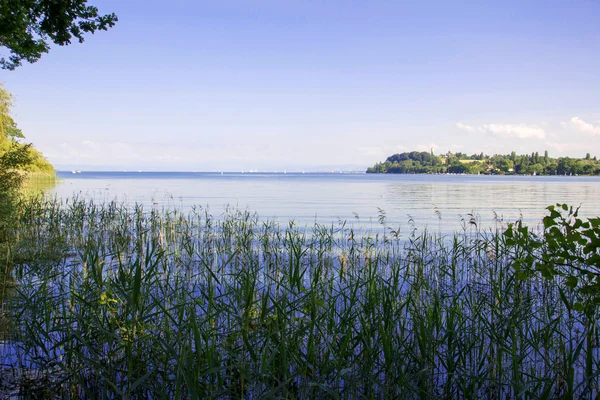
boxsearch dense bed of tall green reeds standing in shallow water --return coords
[0,198,600,399]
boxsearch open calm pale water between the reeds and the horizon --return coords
[48,171,600,234]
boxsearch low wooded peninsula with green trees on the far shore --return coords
[367,151,600,175]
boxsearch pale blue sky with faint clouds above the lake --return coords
[0,0,600,171]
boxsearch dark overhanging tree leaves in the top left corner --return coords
[0,0,117,70]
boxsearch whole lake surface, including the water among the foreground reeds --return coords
[0,172,600,398]
